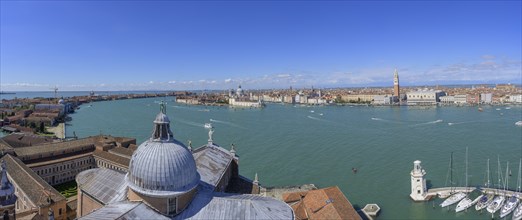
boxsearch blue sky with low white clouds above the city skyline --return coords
[0,1,522,91]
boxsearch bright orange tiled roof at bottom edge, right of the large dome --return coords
[283,186,361,220]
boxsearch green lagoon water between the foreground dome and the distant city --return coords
[67,98,522,219]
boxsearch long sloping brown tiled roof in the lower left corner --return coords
[2,154,65,206]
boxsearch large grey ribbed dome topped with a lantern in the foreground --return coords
[125,102,200,196]
